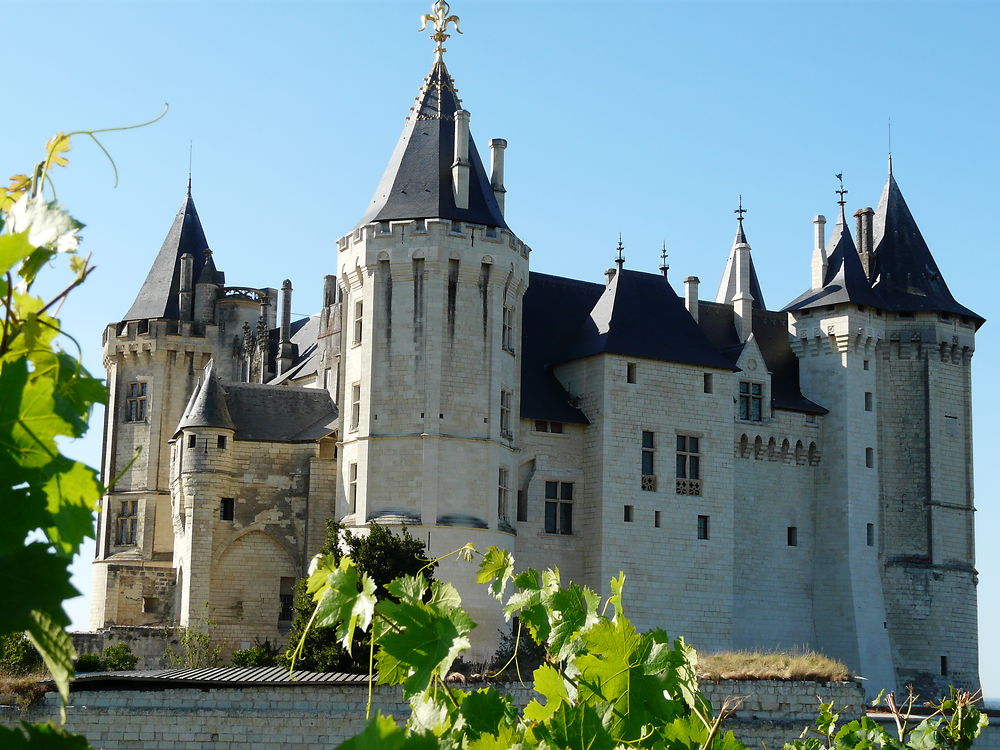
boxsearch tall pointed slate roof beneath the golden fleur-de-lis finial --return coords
[358,60,507,228]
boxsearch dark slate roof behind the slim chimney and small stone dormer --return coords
[698,301,827,414]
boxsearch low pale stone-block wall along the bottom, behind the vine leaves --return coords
[0,681,864,750]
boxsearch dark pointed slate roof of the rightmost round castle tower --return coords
[872,170,985,325]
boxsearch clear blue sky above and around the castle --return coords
[0,0,1000,697]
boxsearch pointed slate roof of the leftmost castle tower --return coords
[122,184,208,320]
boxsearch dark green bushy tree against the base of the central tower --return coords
[279,520,433,672]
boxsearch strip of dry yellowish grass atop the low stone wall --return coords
[698,651,850,682]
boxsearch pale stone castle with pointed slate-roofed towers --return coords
[91,0,984,693]
